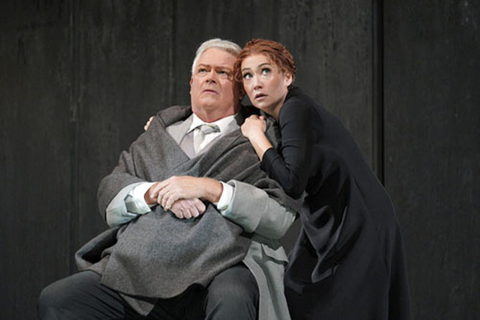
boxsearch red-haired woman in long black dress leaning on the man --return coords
[235,39,410,320]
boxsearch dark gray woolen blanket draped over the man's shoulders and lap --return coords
[76,107,294,314]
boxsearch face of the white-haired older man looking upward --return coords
[190,48,240,122]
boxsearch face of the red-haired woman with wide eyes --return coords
[241,54,292,119]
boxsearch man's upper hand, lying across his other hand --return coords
[145,176,223,210]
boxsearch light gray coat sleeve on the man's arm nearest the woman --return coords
[222,180,296,239]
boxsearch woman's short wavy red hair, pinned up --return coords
[234,39,296,84]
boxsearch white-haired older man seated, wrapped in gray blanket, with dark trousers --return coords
[39,39,297,319]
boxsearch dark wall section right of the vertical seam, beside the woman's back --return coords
[384,0,480,319]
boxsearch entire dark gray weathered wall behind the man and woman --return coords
[0,0,480,319]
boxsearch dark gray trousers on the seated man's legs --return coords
[38,264,259,320]
